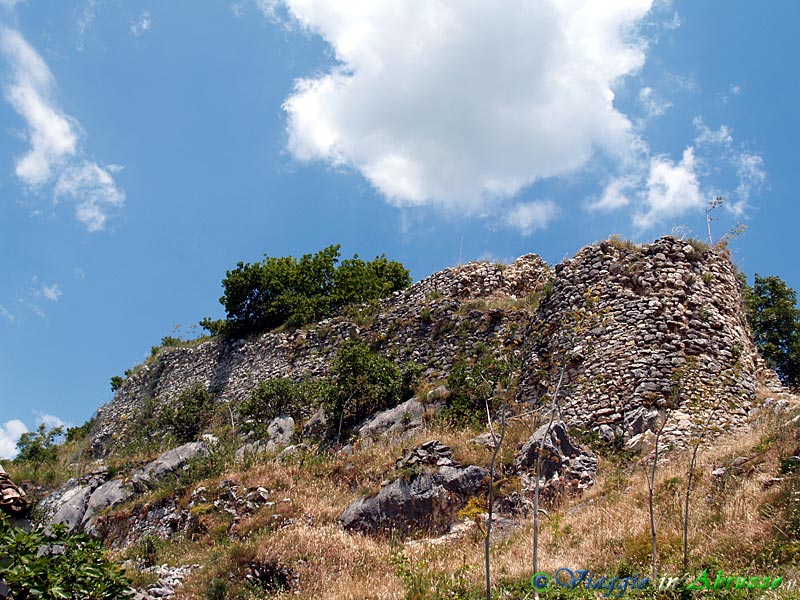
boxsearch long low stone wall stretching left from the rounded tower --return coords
[92,255,552,457]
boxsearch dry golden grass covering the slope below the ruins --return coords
[119,396,800,600]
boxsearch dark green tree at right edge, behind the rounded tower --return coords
[745,274,800,387]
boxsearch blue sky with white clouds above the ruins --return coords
[0,0,800,456]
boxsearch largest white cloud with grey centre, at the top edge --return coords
[272,0,652,212]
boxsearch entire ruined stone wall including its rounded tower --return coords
[91,237,775,457]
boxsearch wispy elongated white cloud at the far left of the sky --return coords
[0,27,125,231]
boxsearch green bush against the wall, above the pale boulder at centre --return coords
[321,341,415,441]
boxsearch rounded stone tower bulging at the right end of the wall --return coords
[518,237,758,443]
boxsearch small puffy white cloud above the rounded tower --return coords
[633,146,706,229]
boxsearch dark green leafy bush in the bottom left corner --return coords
[0,513,132,600]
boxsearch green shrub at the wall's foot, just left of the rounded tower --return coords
[441,351,512,427]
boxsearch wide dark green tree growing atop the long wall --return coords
[219,245,411,334]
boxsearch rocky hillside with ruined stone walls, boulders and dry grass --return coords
[9,237,800,600]
